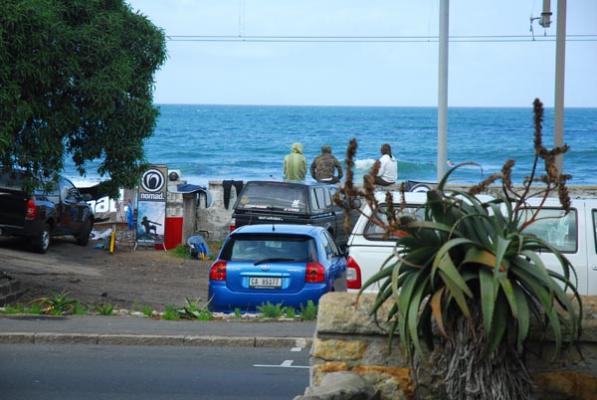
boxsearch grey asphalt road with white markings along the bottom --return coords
[0,345,309,400]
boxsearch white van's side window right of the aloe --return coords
[523,208,578,253]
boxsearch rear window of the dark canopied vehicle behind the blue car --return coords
[237,183,307,212]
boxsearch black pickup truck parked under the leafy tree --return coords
[0,172,93,253]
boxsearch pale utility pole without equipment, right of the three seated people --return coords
[437,0,450,181]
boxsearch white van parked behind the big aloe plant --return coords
[347,192,597,295]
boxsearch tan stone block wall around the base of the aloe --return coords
[310,293,597,400]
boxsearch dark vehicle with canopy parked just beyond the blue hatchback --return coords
[230,181,350,247]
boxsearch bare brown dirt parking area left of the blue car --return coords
[0,237,210,309]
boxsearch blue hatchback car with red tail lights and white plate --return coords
[209,224,346,311]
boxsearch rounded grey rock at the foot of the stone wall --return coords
[301,372,379,400]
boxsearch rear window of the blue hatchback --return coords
[221,235,317,262]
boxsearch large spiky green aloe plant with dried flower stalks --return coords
[337,100,582,400]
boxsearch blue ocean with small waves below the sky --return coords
[65,105,597,185]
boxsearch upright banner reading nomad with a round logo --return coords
[137,165,168,245]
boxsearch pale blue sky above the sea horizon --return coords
[129,0,597,107]
